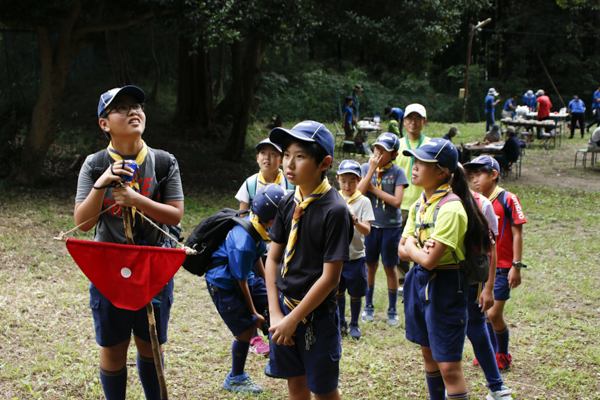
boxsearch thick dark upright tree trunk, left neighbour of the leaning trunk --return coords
[175,36,215,127]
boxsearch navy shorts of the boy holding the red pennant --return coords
[90,279,174,347]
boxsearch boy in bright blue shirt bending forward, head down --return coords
[206,184,285,394]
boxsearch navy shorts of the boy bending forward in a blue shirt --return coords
[206,276,268,336]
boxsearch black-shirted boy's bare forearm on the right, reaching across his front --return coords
[269,260,344,346]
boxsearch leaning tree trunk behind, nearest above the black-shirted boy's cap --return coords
[224,38,267,160]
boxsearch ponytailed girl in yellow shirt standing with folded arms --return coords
[398,138,491,400]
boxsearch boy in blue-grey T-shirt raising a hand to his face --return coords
[358,132,408,326]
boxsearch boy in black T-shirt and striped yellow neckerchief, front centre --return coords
[265,121,354,400]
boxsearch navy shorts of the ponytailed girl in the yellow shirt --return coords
[404,264,469,362]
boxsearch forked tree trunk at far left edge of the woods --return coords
[15,9,81,184]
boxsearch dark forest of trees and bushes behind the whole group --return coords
[0,0,600,184]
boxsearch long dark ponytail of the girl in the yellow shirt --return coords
[450,166,492,253]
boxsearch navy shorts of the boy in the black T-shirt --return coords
[269,295,342,394]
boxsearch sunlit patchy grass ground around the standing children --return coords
[0,120,600,400]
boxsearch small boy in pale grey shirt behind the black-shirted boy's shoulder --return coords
[335,160,375,340]
